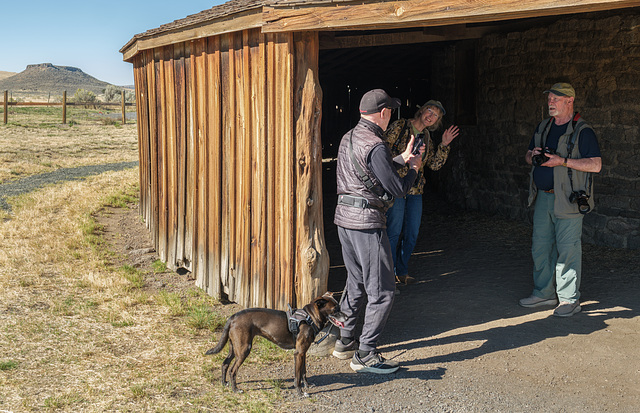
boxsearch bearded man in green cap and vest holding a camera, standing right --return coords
[519,83,602,317]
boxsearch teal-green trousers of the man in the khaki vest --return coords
[531,191,582,303]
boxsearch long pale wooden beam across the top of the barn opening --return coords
[262,0,640,33]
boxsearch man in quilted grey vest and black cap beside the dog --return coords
[333,89,424,374]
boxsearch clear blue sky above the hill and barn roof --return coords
[0,0,224,86]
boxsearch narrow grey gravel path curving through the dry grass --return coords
[0,161,138,211]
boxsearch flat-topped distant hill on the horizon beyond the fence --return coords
[0,63,109,96]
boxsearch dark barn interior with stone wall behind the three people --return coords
[319,9,640,287]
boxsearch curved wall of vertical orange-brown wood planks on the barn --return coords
[134,29,329,309]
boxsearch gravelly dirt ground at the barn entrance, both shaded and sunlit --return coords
[99,195,640,412]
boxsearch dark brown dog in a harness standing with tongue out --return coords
[205,293,346,396]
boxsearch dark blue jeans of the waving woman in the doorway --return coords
[387,195,422,277]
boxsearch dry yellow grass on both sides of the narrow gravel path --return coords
[0,108,291,412]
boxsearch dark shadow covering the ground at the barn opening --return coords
[325,184,640,360]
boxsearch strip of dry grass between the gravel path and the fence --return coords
[0,106,138,182]
